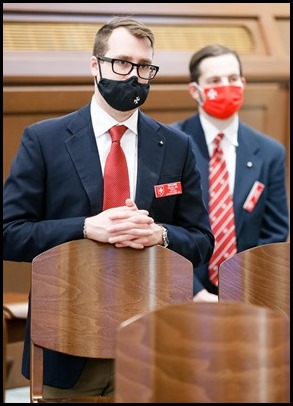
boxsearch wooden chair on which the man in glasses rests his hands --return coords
[31,239,193,402]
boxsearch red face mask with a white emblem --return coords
[202,85,243,120]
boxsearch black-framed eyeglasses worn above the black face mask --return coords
[97,56,159,80]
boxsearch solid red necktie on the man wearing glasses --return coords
[103,125,130,210]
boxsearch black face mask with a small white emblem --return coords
[96,76,150,111]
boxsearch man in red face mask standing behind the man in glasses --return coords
[171,45,288,301]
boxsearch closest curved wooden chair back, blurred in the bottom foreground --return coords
[115,302,290,403]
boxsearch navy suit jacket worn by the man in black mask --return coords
[3,104,214,388]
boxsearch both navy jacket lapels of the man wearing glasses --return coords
[62,105,166,213]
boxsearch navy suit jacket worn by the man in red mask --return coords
[171,114,289,293]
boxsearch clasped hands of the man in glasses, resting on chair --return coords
[85,199,162,249]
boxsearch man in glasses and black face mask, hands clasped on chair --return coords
[3,17,214,397]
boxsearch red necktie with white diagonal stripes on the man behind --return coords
[209,134,237,285]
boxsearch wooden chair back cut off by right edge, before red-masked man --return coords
[219,242,290,317]
